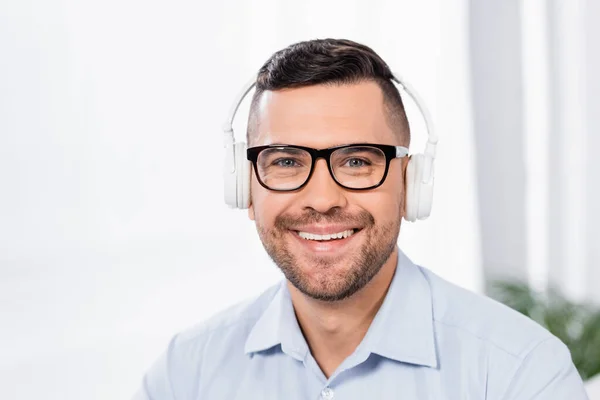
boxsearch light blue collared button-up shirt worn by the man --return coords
[135,248,587,400]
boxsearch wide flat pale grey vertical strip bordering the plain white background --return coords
[469,0,527,283]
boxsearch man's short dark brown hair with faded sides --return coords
[246,39,410,147]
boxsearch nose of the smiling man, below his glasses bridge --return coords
[302,159,347,214]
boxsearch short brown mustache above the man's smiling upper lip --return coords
[274,208,375,230]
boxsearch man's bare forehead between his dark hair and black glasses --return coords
[253,82,397,148]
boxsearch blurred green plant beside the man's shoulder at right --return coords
[490,281,600,380]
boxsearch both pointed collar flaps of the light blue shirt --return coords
[245,250,438,367]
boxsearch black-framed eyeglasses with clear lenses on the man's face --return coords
[247,143,408,192]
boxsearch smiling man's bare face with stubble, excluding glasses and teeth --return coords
[248,82,406,301]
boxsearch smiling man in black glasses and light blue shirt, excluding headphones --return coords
[137,39,586,400]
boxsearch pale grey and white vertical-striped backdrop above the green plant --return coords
[470,0,600,302]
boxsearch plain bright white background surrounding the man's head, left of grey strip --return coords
[0,0,481,400]
